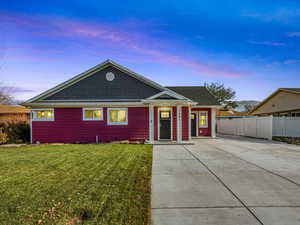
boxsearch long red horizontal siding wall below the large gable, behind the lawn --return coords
[32,107,149,143]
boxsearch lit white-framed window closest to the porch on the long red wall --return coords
[107,108,128,125]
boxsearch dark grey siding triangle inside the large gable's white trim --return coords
[44,66,160,101]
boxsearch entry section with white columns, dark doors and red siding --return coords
[149,103,216,145]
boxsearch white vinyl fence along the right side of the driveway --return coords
[217,116,300,139]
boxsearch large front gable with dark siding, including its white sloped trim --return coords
[25,60,165,105]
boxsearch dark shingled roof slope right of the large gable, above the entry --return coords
[166,86,220,105]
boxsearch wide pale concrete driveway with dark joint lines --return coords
[152,136,300,225]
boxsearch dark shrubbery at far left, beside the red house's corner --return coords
[0,122,30,144]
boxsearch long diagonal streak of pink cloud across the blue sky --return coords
[0,11,245,77]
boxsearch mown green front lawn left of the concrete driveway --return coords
[0,144,152,225]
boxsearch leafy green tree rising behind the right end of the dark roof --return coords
[204,82,238,109]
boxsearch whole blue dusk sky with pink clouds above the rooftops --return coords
[0,0,300,100]
